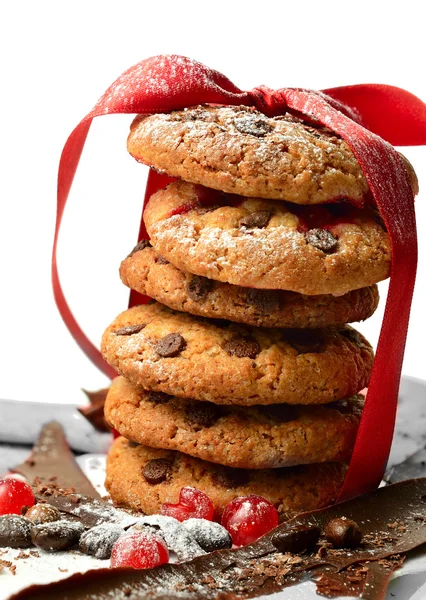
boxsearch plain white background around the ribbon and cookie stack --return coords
[0,0,426,402]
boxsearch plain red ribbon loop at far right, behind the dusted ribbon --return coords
[323,83,426,146]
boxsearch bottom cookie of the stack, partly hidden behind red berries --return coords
[105,437,346,518]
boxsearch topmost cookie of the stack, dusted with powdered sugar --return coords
[127,106,369,204]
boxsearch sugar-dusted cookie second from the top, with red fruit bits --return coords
[144,181,391,296]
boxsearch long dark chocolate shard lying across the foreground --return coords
[12,479,426,600]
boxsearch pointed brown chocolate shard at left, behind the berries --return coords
[13,421,100,502]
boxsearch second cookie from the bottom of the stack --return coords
[105,377,364,469]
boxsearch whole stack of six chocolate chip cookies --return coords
[102,106,415,517]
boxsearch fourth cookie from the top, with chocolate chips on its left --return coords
[101,303,373,405]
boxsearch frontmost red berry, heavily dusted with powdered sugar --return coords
[111,531,169,569]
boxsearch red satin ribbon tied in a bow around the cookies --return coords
[52,56,426,500]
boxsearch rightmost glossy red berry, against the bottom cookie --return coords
[222,494,278,546]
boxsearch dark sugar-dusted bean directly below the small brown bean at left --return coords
[31,521,84,552]
